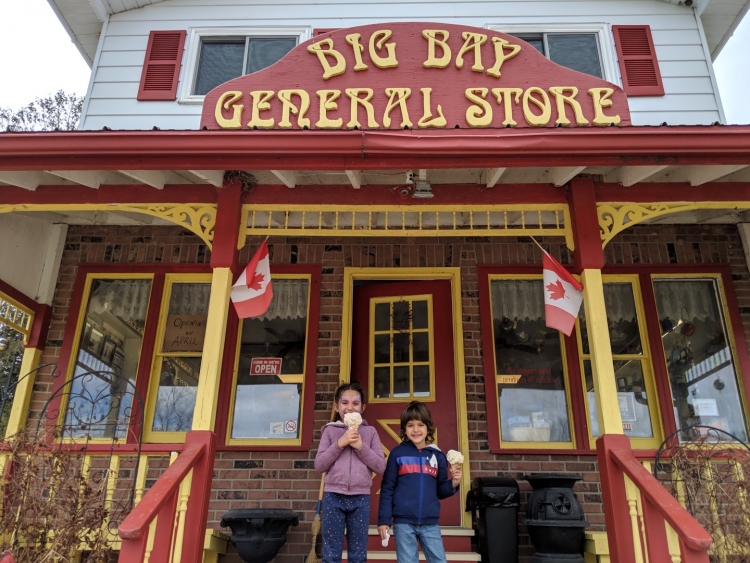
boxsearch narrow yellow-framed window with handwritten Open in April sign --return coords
[149,275,211,441]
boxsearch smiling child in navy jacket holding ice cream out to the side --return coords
[378,401,461,563]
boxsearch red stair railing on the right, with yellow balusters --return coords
[597,434,712,563]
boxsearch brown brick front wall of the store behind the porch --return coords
[34,225,750,563]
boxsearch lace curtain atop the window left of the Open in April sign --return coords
[88,280,151,326]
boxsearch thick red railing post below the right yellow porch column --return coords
[596,434,640,563]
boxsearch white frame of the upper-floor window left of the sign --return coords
[177,26,312,104]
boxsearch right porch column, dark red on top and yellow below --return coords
[568,178,623,436]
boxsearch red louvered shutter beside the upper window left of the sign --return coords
[138,30,187,100]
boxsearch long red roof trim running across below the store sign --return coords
[0,126,750,170]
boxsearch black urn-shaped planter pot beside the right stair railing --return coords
[524,473,589,563]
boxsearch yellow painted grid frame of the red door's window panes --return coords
[367,294,435,403]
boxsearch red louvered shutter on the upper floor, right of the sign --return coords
[612,25,664,96]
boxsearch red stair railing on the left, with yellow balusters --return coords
[118,430,216,563]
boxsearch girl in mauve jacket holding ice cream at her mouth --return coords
[315,381,385,563]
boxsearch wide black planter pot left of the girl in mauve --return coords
[221,508,299,563]
